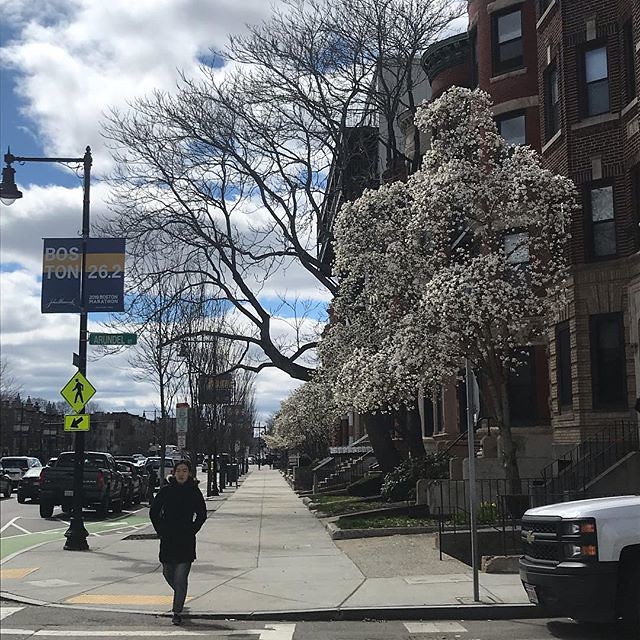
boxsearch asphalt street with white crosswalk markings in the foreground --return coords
[0,602,622,640]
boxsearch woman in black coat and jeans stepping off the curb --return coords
[149,460,207,624]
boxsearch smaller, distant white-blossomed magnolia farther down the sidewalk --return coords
[265,381,340,458]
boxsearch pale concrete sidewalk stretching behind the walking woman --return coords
[1,468,536,620]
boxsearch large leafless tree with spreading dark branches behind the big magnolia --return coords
[100,0,462,380]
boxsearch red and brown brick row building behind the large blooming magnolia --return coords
[423,0,640,462]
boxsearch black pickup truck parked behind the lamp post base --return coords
[40,451,124,518]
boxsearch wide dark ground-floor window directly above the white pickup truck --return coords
[589,313,627,409]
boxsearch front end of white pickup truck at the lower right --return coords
[520,496,640,637]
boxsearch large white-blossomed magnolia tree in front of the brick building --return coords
[321,87,575,490]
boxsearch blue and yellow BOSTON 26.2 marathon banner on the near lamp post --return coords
[41,238,125,313]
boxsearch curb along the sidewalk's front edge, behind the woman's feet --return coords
[0,591,549,622]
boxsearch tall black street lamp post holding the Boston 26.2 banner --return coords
[0,147,92,551]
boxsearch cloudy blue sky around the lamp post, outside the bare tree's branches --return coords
[0,0,314,420]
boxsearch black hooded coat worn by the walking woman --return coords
[149,477,207,564]
